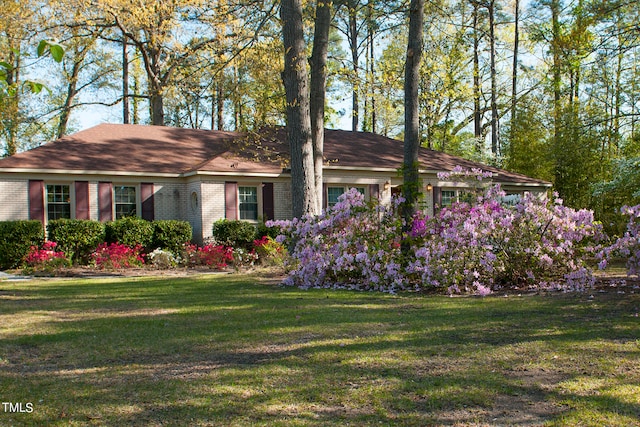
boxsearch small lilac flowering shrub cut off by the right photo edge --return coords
[597,205,640,276]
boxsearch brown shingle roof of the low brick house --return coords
[0,124,548,185]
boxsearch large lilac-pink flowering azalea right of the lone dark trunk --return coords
[407,190,602,295]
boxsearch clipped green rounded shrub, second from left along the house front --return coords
[47,219,104,264]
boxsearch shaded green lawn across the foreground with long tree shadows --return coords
[0,274,640,426]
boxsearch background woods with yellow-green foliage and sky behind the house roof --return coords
[0,0,640,229]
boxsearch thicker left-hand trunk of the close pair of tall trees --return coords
[280,0,319,218]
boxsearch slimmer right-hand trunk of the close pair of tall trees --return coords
[310,0,331,212]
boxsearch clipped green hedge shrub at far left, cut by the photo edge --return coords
[0,221,44,270]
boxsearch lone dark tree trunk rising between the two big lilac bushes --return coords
[402,0,425,227]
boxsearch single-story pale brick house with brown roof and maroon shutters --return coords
[0,124,551,242]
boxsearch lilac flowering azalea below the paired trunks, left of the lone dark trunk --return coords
[267,189,407,291]
